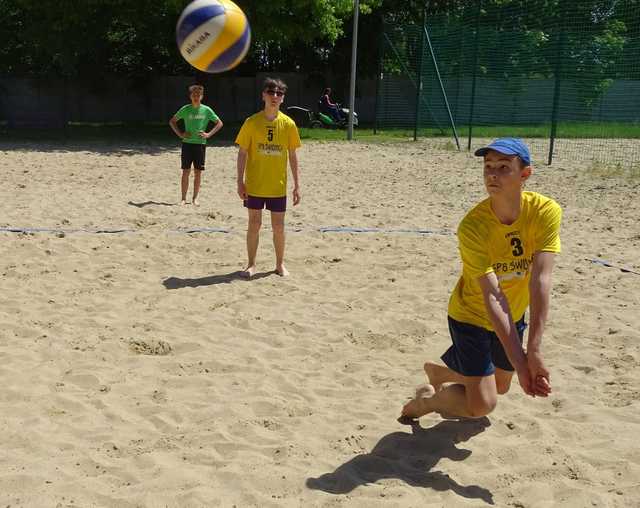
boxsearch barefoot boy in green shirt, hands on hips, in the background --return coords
[169,85,222,206]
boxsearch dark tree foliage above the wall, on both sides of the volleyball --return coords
[0,0,382,77]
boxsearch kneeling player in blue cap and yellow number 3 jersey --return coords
[402,138,562,419]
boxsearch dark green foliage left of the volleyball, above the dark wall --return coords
[0,0,186,78]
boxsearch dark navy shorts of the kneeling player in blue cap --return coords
[441,316,527,377]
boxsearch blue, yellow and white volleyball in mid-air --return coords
[176,0,251,73]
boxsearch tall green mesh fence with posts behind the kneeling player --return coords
[376,0,640,166]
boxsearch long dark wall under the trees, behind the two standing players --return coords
[0,74,375,127]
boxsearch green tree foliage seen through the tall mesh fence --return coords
[382,0,640,114]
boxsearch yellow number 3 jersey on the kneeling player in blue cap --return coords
[448,192,562,330]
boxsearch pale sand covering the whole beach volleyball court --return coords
[0,137,640,508]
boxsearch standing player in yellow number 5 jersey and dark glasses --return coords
[236,78,300,278]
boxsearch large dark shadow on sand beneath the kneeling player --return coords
[306,418,494,504]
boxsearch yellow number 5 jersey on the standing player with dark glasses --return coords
[236,111,301,198]
